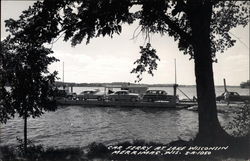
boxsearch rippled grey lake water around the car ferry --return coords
[0,87,249,147]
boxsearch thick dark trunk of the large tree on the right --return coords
[189,1,229,145]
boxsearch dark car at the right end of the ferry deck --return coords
[142,90,179,102]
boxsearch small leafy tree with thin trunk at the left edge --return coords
[0,35,56,154]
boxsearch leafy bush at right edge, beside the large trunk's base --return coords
[226,104,250,137]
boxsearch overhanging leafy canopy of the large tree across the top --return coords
[3,0,249,80]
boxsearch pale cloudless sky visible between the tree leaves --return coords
[1,0,249,85]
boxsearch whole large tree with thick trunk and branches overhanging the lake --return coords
[2,0,249,144]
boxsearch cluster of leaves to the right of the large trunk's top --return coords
[210,1,250,56]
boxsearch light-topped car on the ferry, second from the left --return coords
[77,90,104,101]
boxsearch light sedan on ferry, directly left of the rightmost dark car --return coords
[108,90,140,102]
